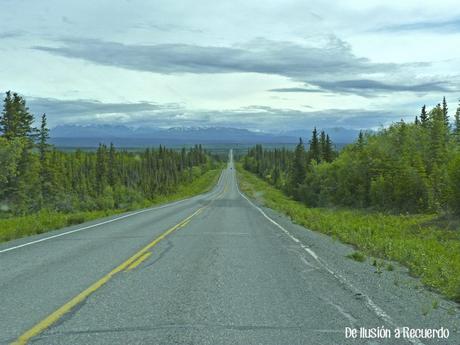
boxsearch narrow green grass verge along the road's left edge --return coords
[0,168,221,242]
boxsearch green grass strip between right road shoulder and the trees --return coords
[237,165,460,302]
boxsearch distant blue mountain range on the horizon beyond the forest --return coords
[50,125,358,147]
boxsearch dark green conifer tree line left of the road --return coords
[0,91,216,216]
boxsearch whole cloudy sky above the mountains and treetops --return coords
[0,0,460,132]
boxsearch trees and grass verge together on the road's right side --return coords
[238,99,460,301]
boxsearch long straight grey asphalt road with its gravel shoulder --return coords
[0,151,460,345]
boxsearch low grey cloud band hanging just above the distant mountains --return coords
[28,98,401,132]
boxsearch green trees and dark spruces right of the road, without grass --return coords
[243,98,460,214]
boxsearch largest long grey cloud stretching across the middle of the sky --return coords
[34,37,398,80]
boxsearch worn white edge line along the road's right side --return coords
[236,175,424,345]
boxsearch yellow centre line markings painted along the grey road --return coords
[12,200,210,345]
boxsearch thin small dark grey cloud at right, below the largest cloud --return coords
[269,79,458,96]
